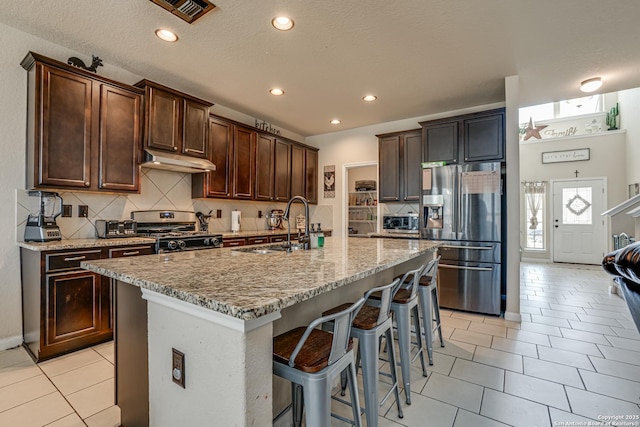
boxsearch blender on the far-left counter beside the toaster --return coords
[24,191,62,242]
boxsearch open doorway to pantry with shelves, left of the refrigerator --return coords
[342,162,379,237]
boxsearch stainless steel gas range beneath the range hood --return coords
[131,210,222,253]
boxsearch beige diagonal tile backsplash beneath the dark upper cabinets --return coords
[16,168,333,240]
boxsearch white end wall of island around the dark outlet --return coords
[147,301,273,427]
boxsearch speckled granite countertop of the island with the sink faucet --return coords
[81,237,439,320]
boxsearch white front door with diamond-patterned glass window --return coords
[552,179,606,264]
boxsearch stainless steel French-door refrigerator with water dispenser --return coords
[420,163,503,315]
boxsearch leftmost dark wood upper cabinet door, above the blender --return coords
[33,64,93,188]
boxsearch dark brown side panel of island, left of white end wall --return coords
[114,281,149,427]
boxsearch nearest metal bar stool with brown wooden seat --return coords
[273,298,364,427]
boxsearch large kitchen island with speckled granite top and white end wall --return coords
[82,237,438,427]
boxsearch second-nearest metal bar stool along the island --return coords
[322,279,404,427]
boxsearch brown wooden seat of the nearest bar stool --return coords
[273,328,353,373]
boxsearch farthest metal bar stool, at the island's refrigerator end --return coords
[418,257,444,365]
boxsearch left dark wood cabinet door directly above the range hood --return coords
[146,87,183,152]
